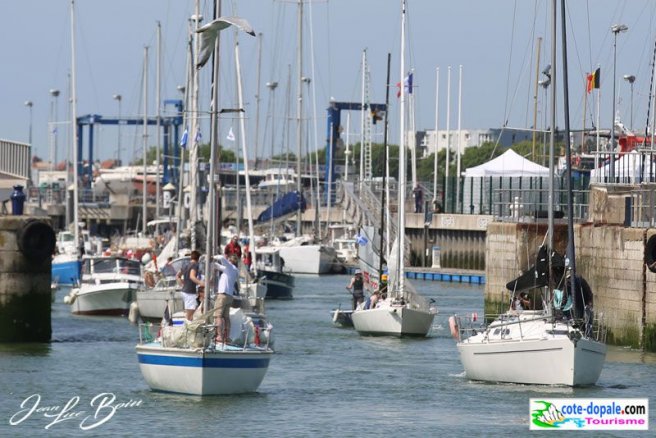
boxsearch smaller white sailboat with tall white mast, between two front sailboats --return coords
[351,0,437,337]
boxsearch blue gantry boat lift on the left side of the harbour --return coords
[75,99,183,187]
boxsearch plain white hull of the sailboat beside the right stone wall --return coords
[457,326,607,386]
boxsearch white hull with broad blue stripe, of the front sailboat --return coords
[136,343,273,395]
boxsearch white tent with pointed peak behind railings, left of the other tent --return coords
[462,149,549,216]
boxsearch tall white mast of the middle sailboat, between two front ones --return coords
[397,0,406,296]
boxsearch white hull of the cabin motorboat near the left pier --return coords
[71,282,139,316]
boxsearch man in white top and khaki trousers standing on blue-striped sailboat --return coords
[214,254,239,344]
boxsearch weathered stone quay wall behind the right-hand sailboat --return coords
[485,222,656,351]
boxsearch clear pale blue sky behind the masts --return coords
[0,0,656,166]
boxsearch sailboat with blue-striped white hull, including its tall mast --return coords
[136,10,273,395]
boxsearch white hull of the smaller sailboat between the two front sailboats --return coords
[351,306,435,337]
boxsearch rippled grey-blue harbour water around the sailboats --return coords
[0,276,656,437]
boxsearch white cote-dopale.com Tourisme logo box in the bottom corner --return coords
[529,398,649,430]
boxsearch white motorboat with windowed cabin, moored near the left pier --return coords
[65,256,143,315]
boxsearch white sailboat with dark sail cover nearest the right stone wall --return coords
[449,0,607,386]
